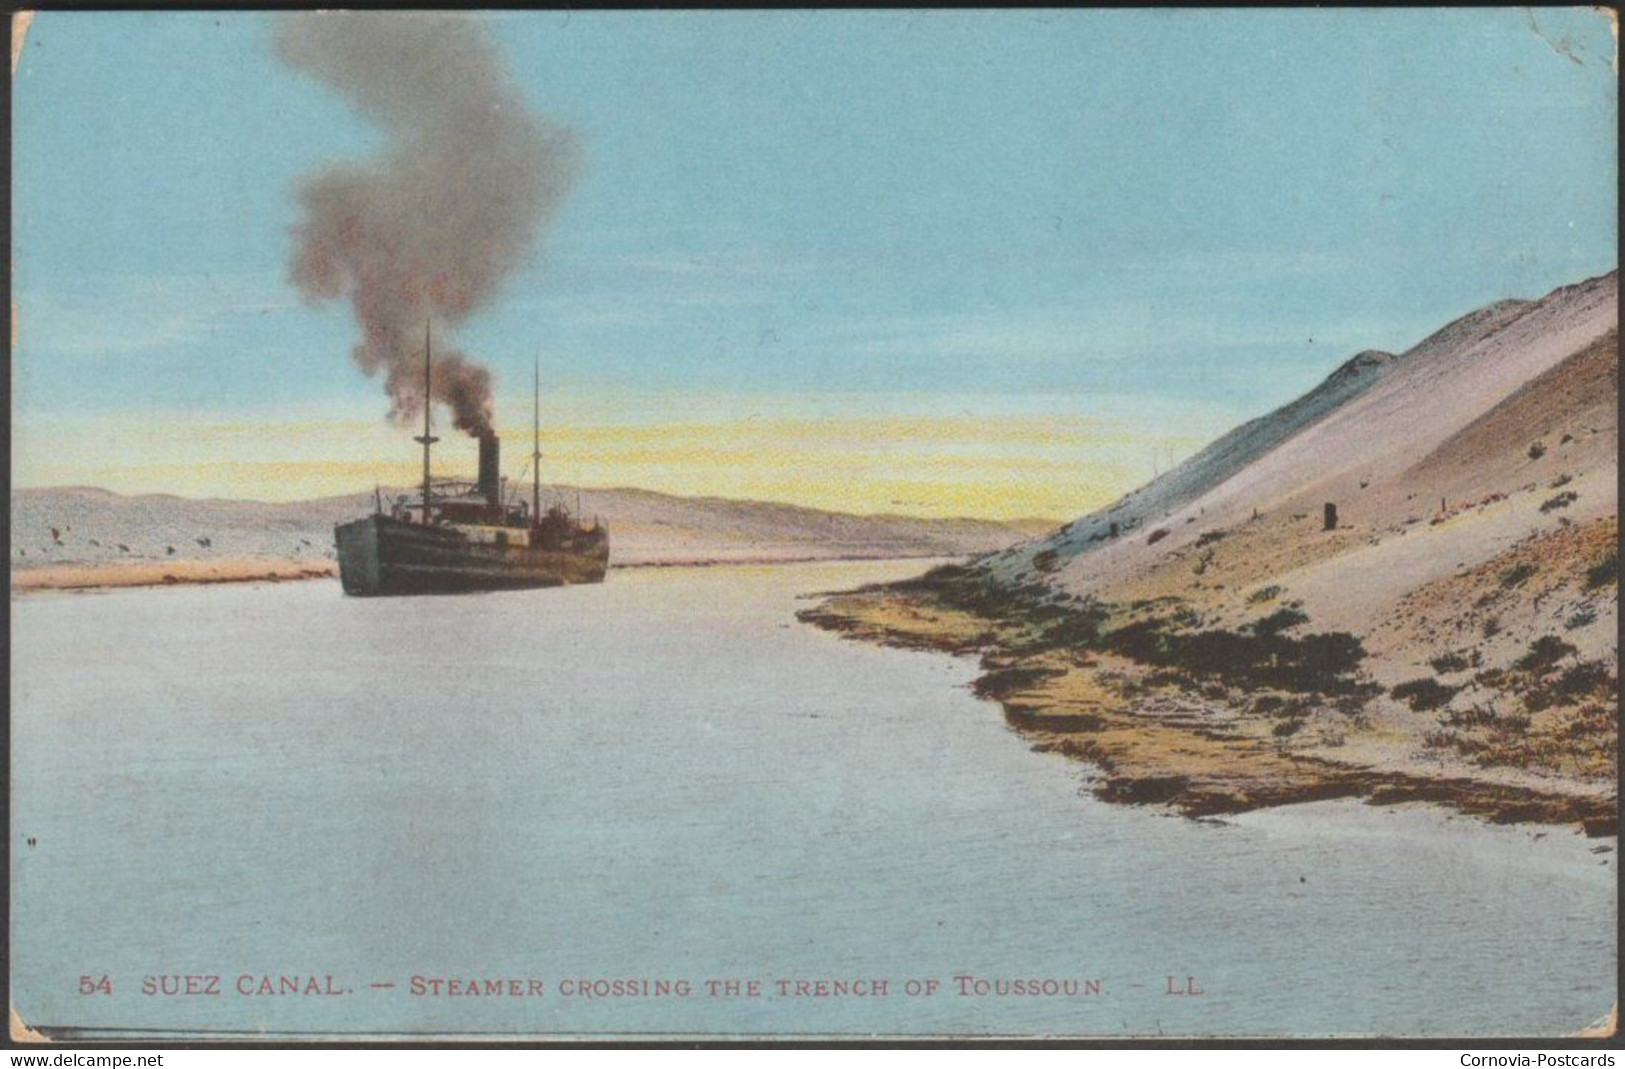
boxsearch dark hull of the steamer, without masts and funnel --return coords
[333,515,609,598]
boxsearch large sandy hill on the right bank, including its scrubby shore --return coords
[809,273,1619,817]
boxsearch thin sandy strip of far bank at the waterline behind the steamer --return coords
[11,552,952,595]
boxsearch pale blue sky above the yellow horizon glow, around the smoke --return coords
[13,10,1617,422]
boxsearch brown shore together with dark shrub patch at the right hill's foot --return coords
[801,567,1615,833]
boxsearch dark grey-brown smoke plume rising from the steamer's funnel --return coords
[276,11,577,434]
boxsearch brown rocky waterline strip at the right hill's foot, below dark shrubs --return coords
[796,580,1619,837]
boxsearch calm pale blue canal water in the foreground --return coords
[10,562,1617,1037]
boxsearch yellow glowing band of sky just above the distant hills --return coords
[13,404,1228,520]
